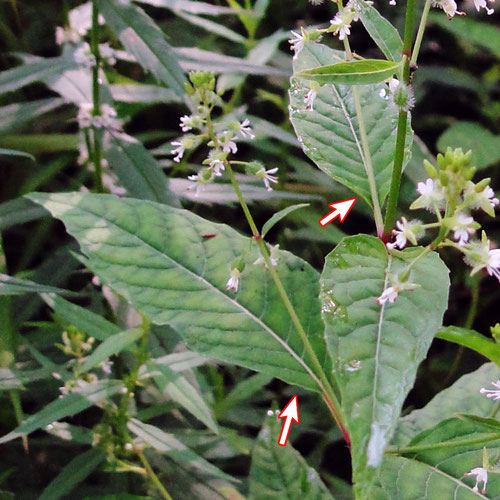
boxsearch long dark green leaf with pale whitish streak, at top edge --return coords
[96,0,186,97]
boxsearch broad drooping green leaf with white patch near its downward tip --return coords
[321,235,449,496]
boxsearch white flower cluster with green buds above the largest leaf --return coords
[171,71,278,196]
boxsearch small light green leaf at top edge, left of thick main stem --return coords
[358,0,403,61]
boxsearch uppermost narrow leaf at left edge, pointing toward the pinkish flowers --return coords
[0,56,76,94]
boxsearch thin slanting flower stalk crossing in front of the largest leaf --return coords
[224,160,350,443]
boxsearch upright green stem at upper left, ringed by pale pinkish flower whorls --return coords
[89,0,104,193]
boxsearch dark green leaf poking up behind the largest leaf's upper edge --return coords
[104,133,179,204]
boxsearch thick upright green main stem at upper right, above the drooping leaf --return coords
[383,0,415,241]
